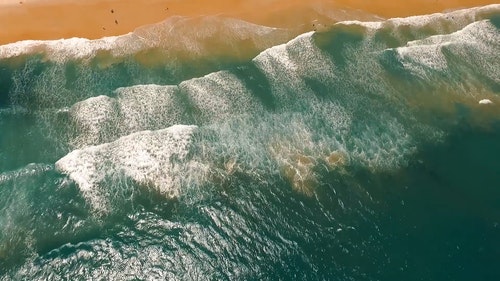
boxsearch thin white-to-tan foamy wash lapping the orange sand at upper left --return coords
[0,16,290,63]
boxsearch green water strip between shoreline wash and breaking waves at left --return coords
[0,52,246,111]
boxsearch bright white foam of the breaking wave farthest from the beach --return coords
[56,125,197,210]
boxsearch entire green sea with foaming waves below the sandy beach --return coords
[0,5,500,280]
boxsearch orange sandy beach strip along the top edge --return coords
[0,0,496,44]
